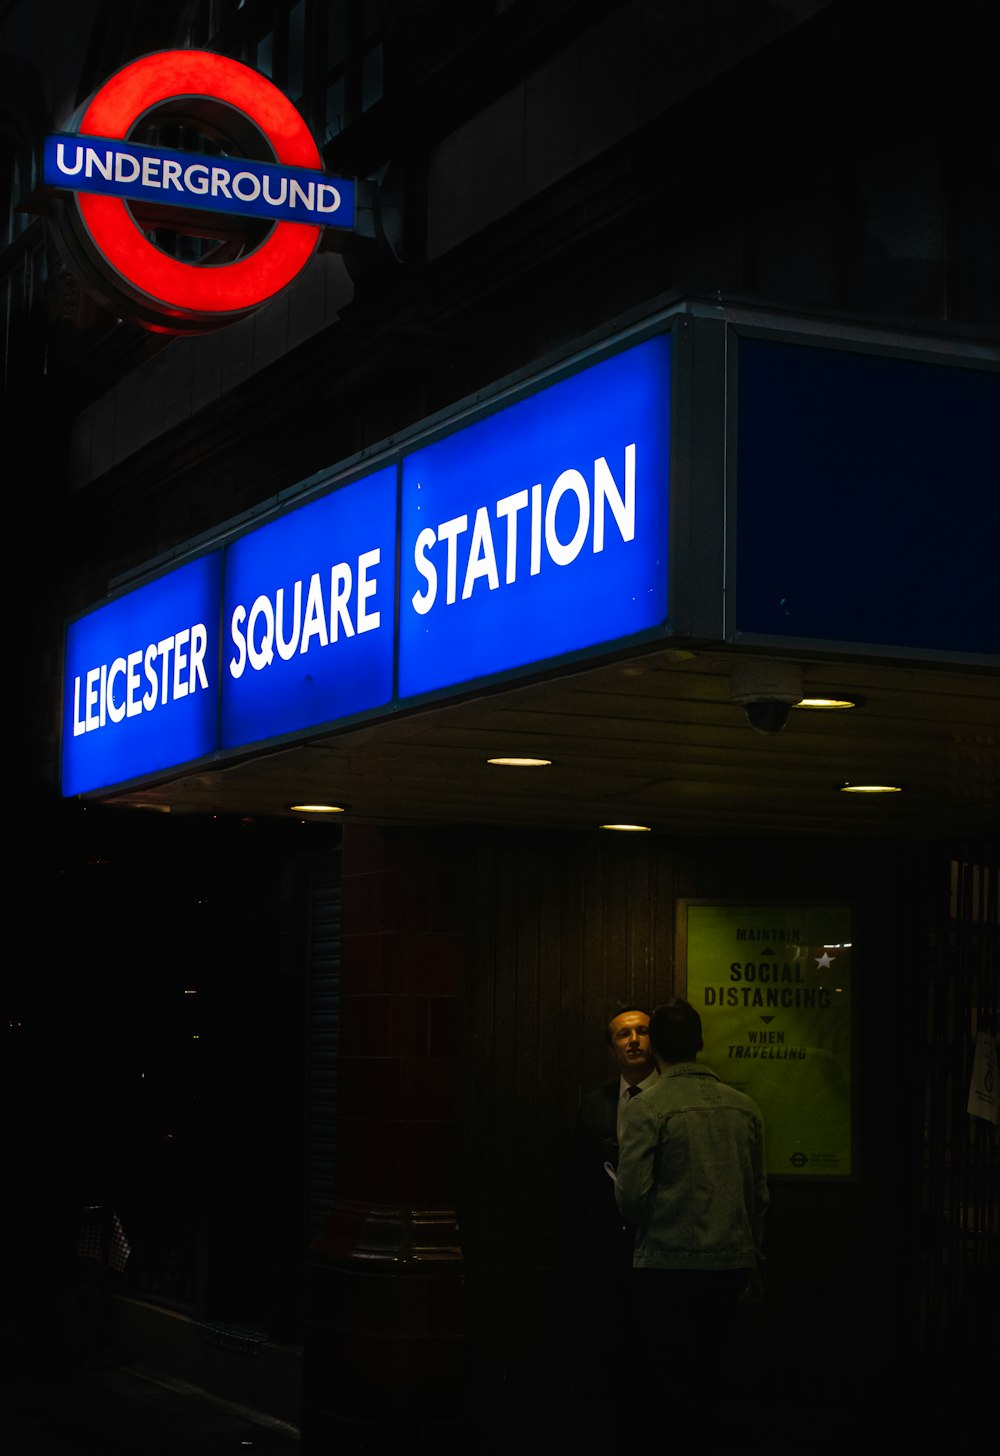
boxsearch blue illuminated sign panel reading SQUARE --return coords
[223,466,396,748]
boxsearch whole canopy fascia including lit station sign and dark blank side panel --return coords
[63,304,1000,795]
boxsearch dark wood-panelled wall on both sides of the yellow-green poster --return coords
[459,830,949,1389]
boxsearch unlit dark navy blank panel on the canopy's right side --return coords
[737,338,1000,654]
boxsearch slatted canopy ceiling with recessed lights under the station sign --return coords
[103,646,1000,836]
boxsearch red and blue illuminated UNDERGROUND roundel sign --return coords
[45,51,352,332]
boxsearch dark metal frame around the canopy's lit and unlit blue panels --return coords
[62,294,1000,792]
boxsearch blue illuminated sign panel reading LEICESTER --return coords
[63,552,223,794]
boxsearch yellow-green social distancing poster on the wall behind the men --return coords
[683,903,854,1176]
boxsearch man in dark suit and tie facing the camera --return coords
[565,1006,658,1389]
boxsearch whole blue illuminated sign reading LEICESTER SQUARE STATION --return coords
[63,333,671,795]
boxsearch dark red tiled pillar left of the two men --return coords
[303,826,464,1456]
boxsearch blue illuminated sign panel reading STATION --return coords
[399,335,670,697]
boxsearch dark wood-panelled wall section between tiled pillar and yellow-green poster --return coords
[460,831,677,1383]
